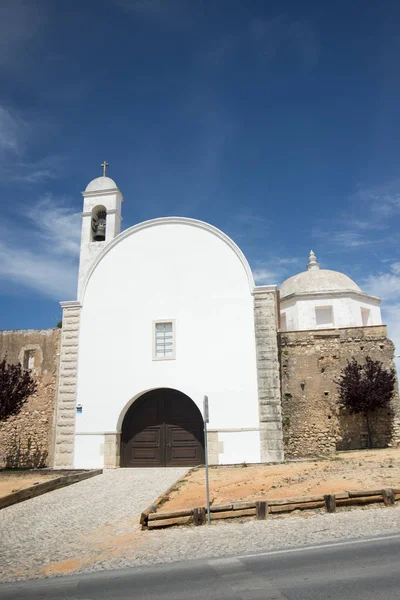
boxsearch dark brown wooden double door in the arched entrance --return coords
[121,388,204,467]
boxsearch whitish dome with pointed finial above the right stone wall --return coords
[279,251,362,299]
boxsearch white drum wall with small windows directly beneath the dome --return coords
[280,293,382,331]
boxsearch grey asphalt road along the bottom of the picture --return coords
[0,535,400,600]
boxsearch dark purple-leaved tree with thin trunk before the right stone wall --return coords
[336,356,396,448]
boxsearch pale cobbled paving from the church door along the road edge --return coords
[0,469,400,581]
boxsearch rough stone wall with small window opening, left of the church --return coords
[0,329,60,467]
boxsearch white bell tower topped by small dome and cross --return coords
[78,161,123,300]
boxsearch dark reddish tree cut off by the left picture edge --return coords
[0,358,37,422]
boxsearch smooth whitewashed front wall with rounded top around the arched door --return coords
[75,218,260,467]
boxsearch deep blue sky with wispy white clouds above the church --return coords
[0,0,400,352]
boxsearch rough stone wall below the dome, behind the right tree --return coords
[279,325,400,458]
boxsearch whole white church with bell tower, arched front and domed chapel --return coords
[54,169,390,468]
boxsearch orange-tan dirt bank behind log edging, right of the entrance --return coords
[160,448,400,511]
